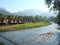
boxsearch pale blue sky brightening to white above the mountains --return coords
[0,0,49,12]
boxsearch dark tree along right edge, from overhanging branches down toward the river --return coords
[45,0,60,25]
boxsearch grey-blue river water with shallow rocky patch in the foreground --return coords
[0,23,60,45]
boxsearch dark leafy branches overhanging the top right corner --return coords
[45,0,60,11]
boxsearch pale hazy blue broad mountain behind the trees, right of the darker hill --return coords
[13,9,55,17]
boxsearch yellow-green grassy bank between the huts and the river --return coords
[0,22,50,31]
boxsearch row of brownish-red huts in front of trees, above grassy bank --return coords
[0,19,34,25]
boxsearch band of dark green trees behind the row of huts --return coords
[0,14,47,23]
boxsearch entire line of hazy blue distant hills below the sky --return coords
[0,8,55,17]
